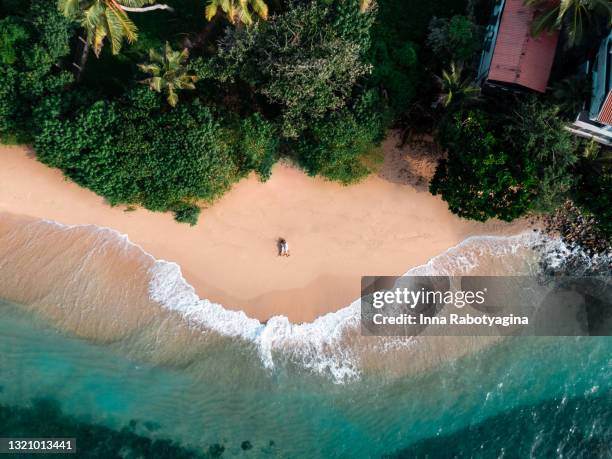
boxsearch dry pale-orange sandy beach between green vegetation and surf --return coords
[0,137,525,323]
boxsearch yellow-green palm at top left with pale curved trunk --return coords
[59,0,172,58]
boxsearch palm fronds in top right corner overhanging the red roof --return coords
[525,0,612,46]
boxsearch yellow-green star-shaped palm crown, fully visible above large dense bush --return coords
[138,42,198,107]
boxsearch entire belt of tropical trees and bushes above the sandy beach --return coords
[0,0,612,237]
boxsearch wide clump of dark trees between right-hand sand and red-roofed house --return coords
[430,99,577,221]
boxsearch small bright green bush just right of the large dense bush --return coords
[235,113,278,182]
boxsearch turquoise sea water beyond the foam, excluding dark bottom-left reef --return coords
[0,303,612,457]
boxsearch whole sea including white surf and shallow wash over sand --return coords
[0,222,612,458]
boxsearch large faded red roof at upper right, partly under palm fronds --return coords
[488,0,559,92]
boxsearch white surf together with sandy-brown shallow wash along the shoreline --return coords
[0,216,596,383]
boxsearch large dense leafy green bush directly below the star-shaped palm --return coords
[35,88,236,225]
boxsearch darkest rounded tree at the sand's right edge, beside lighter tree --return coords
[430,110,536,221]
